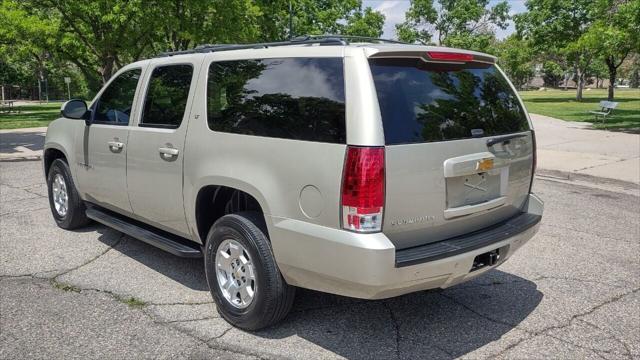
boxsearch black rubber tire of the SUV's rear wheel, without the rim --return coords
[204,211,295,330]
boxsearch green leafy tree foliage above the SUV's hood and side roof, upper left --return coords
[0,0,384,97]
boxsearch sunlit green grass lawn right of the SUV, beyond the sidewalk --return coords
[520,89,640,132]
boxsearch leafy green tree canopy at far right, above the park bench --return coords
[515,0,640,100]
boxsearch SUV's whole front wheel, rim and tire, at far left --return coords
[47,159,89,230]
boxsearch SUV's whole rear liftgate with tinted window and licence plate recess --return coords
[369,56,533,249]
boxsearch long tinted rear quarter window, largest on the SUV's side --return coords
[207,58,346,143]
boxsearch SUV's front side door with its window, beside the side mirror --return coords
[76,68,142,213]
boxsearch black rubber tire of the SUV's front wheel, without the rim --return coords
[47,159,90,230]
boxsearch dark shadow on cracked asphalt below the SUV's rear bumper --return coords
[254,270,543,359]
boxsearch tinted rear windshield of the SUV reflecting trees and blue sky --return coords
[369,58,529,145]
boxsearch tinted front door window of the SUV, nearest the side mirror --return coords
[93,69,141,125]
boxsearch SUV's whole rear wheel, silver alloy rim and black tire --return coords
[205,212,295,330]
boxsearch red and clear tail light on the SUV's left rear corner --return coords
[342,146,385,232]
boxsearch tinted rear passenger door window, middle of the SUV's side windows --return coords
[140,65,193,128]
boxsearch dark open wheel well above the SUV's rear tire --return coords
[196,185,268,244]
